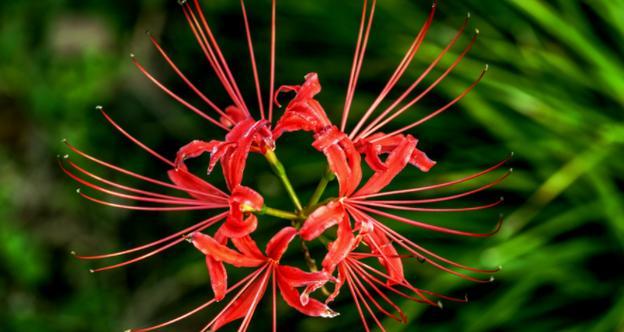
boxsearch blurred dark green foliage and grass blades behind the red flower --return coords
[0,0,624,332]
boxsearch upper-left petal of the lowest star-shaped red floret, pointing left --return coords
[191,232,265,267]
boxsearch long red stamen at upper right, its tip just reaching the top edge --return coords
[349,0,437,139]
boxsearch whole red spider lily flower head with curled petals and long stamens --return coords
[59,0,509,331]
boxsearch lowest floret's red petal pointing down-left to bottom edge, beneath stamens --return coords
[211,271,269,331]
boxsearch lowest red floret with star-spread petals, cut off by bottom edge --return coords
[131,227,338,332]
